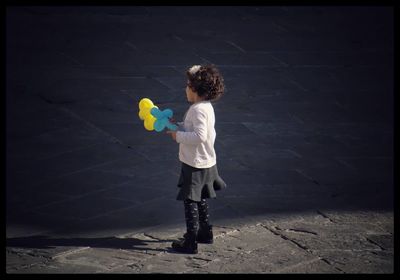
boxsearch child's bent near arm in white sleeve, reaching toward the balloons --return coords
[176,110,207,145]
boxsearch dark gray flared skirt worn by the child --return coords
[176,163,226,201]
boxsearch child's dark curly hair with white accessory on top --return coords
[186,64,225,100]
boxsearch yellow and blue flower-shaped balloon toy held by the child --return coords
[139,98,178,132]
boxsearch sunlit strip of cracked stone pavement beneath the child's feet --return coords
[7,211,393,273]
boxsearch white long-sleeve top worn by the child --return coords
[176,101,217,168]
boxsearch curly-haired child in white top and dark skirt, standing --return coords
[167,65,226,254]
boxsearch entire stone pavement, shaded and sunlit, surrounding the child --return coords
[6,6,399,274]
